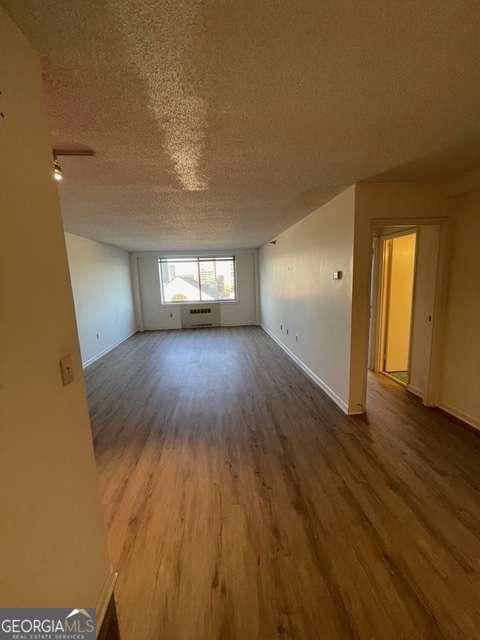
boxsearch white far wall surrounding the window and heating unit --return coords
[132,250,258,330]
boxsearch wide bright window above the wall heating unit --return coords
[158,256,237,304]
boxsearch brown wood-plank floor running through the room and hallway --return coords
[87,327,480,640]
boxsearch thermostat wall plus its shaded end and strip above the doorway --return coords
[260,183,445,413]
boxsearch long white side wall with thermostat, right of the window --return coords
[259,187,355,411]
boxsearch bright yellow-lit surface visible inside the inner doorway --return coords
[385,234,415,371]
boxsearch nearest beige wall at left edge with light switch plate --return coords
[0,9,109,607]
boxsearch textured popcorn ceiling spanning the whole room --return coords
[3,0,480,250]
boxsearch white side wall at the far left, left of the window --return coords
[65,233,136,366]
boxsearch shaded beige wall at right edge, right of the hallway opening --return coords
[440,195,480,427]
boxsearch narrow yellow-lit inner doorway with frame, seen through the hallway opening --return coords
[381,231,417,386]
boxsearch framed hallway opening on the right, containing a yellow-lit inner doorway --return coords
[363,218,449,406]
